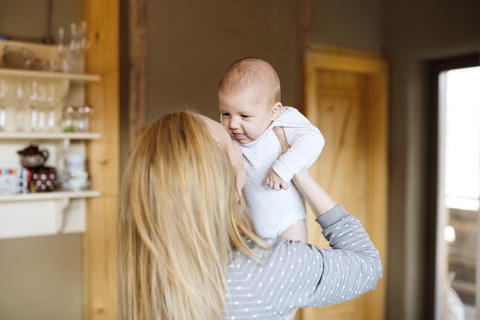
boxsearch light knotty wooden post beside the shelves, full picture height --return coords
[84,0,119,319]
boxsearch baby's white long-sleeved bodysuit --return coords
[241,107,325,238]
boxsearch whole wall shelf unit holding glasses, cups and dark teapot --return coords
[0,37,100,239]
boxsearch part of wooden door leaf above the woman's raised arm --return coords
[311,71,367,223]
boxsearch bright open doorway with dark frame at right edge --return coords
[427,54,480,320]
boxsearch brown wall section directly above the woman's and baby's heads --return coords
[147,0,299,121]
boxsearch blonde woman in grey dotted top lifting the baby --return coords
[118,111,382,320]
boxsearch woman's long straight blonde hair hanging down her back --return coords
[117,111,265,320]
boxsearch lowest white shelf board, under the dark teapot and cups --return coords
[0,190,100,203]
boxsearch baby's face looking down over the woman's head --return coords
[218,86,281,144]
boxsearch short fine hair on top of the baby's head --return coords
[218,57,281,105]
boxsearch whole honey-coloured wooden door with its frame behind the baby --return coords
[300,46,387,320]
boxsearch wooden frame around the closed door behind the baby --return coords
[301,44,388,320]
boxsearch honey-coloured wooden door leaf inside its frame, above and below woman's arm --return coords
[304,70,367,320]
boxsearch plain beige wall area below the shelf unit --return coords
[0,234,83,320]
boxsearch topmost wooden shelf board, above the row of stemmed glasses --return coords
[0,68,100,82]
